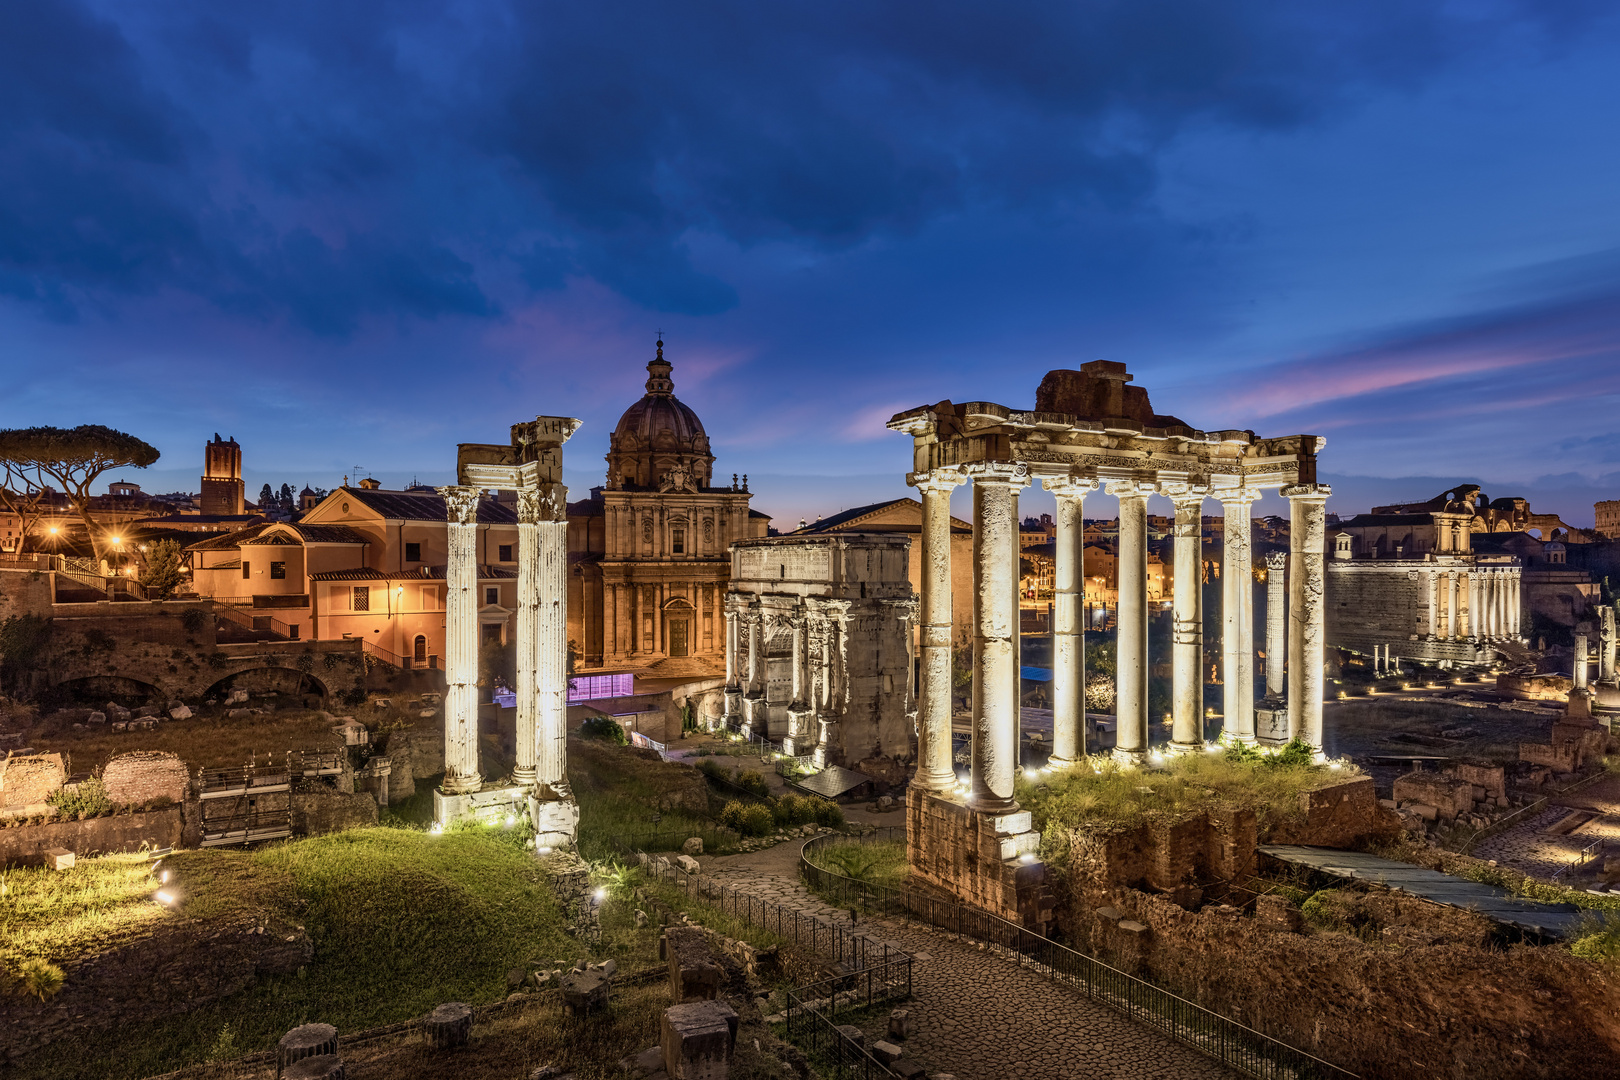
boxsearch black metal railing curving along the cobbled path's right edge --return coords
[799,826,1356,1080]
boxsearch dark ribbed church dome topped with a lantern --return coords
[608,342,714,491]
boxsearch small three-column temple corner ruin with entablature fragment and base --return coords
[434,416,580,848]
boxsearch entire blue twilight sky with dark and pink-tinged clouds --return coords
[0,0,1620,525]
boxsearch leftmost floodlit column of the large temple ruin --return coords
[907,470,966,792]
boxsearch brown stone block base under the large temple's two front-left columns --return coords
[906,790,1051,934]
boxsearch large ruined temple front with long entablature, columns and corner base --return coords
[888,359,1332,925]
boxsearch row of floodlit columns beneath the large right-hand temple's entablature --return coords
[909,463,1332,810]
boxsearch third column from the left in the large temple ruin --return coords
[1042,478,1095,766]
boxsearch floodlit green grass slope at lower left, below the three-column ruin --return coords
[3,827,589,1078]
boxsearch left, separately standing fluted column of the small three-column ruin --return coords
[439,486,483,795]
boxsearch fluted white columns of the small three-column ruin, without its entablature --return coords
[439,484,569,795]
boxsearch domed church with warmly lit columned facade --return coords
[569,342,770,678]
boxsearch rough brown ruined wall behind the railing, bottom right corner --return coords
[1058,891,1620,1080]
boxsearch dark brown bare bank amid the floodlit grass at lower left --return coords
[0,919,314,1057]
